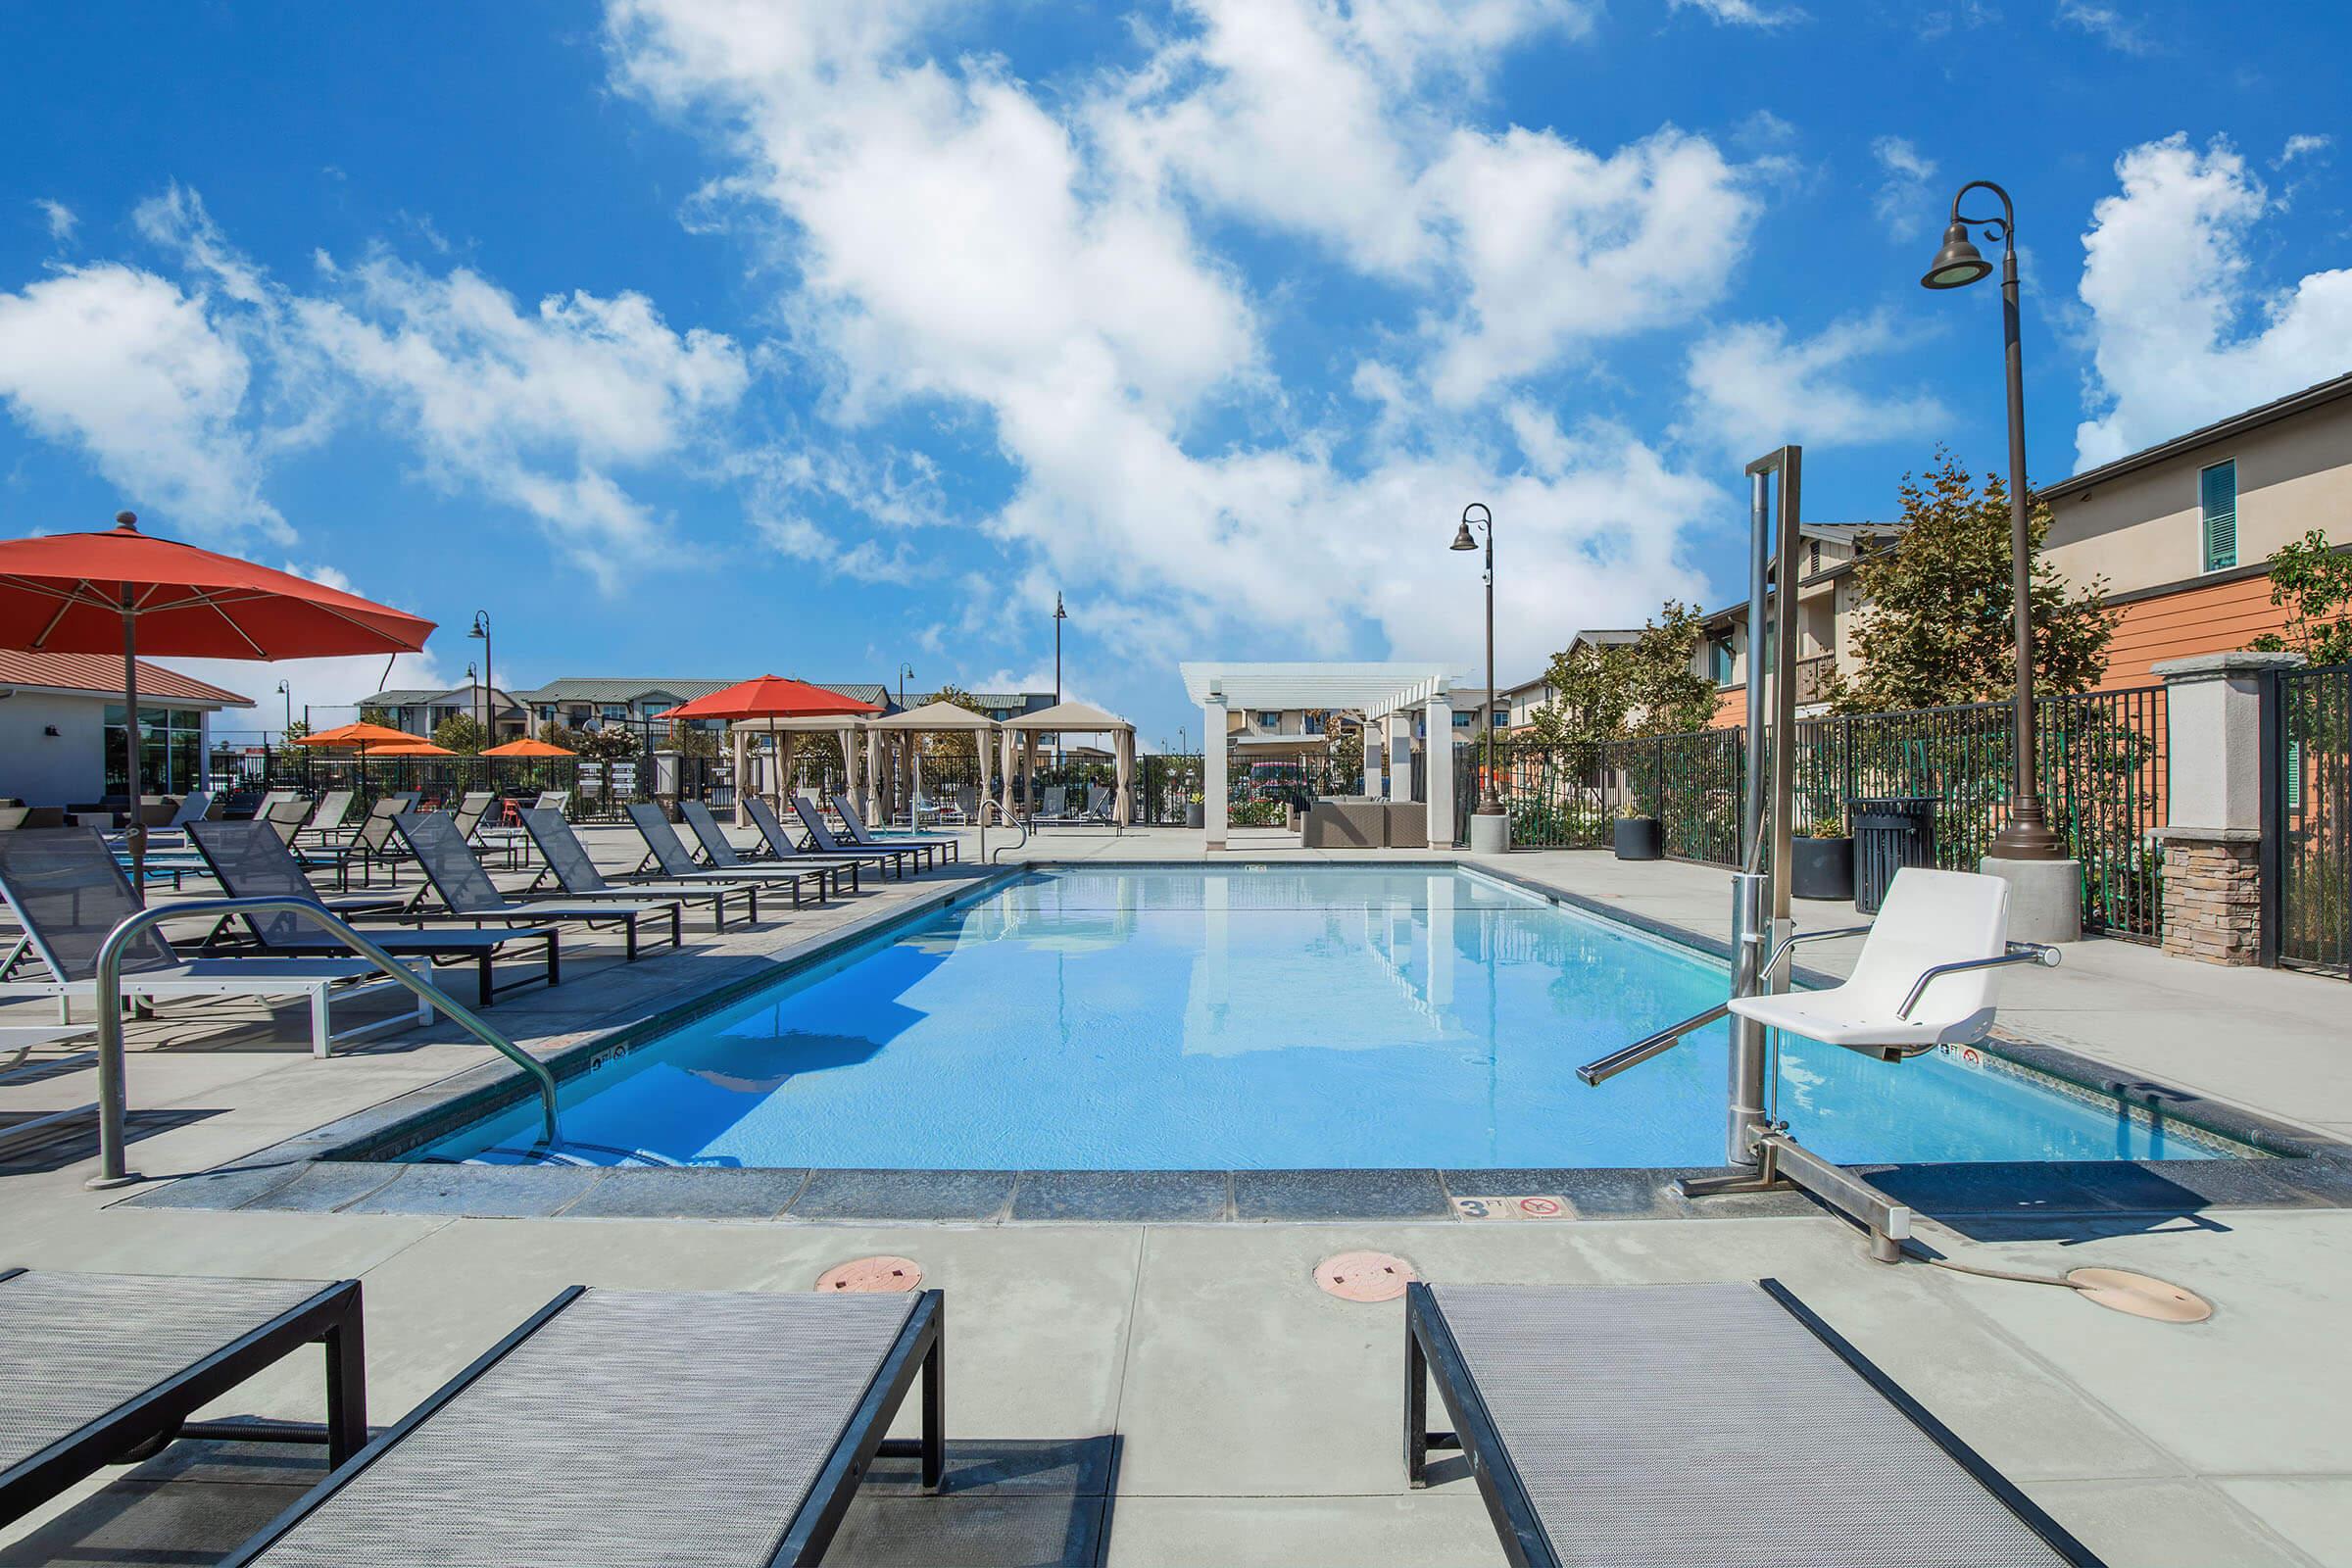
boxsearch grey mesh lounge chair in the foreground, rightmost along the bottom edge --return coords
[1404,1279,2098,1568]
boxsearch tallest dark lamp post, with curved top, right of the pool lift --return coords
[1919,178,2065,860]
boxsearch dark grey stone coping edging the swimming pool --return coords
[124,856,2352,1225]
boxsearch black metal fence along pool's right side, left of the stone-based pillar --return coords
[1456,686,2164,941]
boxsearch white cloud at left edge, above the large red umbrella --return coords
[0,264,292,538]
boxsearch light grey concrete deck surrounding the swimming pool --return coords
[0,832,2352,1566]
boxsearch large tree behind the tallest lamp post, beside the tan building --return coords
[1828,447,2124,712]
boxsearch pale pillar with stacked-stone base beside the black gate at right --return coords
[2154,654,2303,964]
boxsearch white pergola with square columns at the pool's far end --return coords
[1178,662,1453,849]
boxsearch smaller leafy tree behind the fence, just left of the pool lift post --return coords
[1529,600,1715,773]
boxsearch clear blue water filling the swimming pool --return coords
[423,867,2211,1171]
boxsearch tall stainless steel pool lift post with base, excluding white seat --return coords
[1576,447,1912,1262]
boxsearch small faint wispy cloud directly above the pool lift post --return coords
[1684,311,1950,456]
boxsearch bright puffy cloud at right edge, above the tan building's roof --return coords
[2075,134,2352,467]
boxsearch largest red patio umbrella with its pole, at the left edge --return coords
[0,513,433,889]
